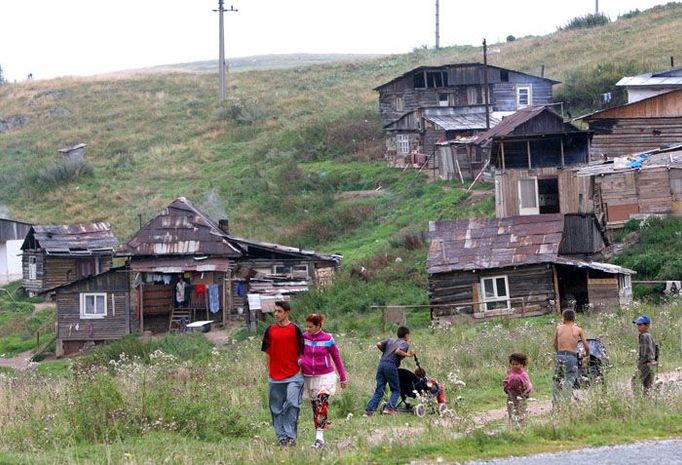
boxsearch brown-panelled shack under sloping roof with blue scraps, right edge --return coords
[577,145,682,230]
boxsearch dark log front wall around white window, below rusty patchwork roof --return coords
[429,264,555,317]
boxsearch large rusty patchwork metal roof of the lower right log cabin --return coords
[427,213,564,273]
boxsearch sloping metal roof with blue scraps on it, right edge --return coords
[576,145,682,176]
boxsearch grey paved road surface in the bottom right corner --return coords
[465,439,682,465]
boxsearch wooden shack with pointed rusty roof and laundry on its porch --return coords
[119,197,340,332]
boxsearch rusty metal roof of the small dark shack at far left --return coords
[21,222,118,256]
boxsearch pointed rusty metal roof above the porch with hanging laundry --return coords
[119,197,242,257]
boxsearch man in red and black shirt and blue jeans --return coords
[261,301,303,447]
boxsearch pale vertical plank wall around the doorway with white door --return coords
[495,168,593,218]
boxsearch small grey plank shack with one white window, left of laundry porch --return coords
[54,268,134,357]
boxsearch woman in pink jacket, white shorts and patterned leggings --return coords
[301,313,348,449]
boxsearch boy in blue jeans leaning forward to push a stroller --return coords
[363,326,415,417]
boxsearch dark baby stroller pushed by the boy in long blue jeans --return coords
[388,355,447,417]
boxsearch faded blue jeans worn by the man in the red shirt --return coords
[268,371,303,441]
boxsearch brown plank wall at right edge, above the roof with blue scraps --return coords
[589,117,682,161]
